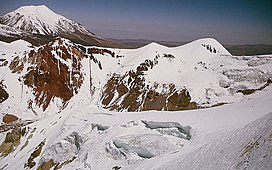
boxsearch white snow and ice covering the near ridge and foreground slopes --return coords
[0,38,272,170]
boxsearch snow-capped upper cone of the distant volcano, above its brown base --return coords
[0,5,93,35]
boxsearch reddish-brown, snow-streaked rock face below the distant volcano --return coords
[20,39,84,110]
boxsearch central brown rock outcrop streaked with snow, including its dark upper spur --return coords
[101,55,198,111]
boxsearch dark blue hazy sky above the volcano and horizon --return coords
[0,0,272,44]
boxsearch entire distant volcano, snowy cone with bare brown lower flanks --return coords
[0,5,124,47]
